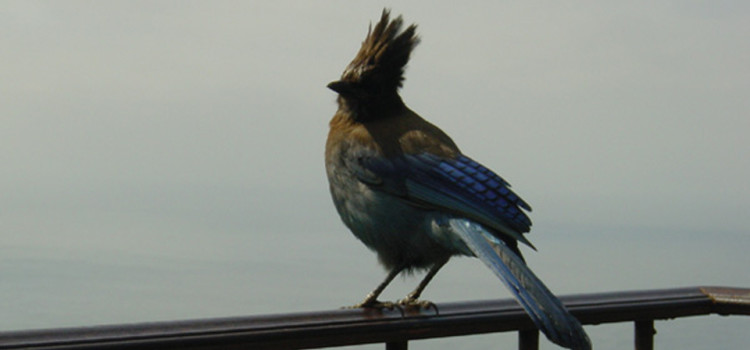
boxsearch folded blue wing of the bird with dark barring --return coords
[360,153,534,248]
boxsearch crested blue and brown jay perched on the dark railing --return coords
[325,8,591,350]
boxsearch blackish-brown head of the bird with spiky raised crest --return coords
[328,9,419,118]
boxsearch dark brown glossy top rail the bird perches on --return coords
[0,287,750,349]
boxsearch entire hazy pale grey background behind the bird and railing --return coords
[0,1,750,349]
